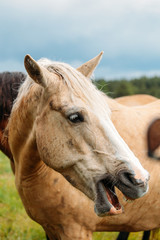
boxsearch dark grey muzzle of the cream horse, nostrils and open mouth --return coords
[95,171,148,217]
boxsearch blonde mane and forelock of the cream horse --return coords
[13,58,110,118]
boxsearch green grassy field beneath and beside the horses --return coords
[0,152,158,240]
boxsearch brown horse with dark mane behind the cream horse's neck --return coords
[0,72,155,240]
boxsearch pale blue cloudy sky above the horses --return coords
[0,0,160,79]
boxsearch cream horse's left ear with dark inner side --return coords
[24,55,47,88]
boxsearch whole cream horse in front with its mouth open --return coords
[8,55,160,240]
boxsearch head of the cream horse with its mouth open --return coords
[10,53,149,216]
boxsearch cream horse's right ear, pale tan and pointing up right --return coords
[77,52,103,78]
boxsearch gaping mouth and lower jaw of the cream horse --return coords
[95,179,122,217]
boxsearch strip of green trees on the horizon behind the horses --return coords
[95,76,160,98]
